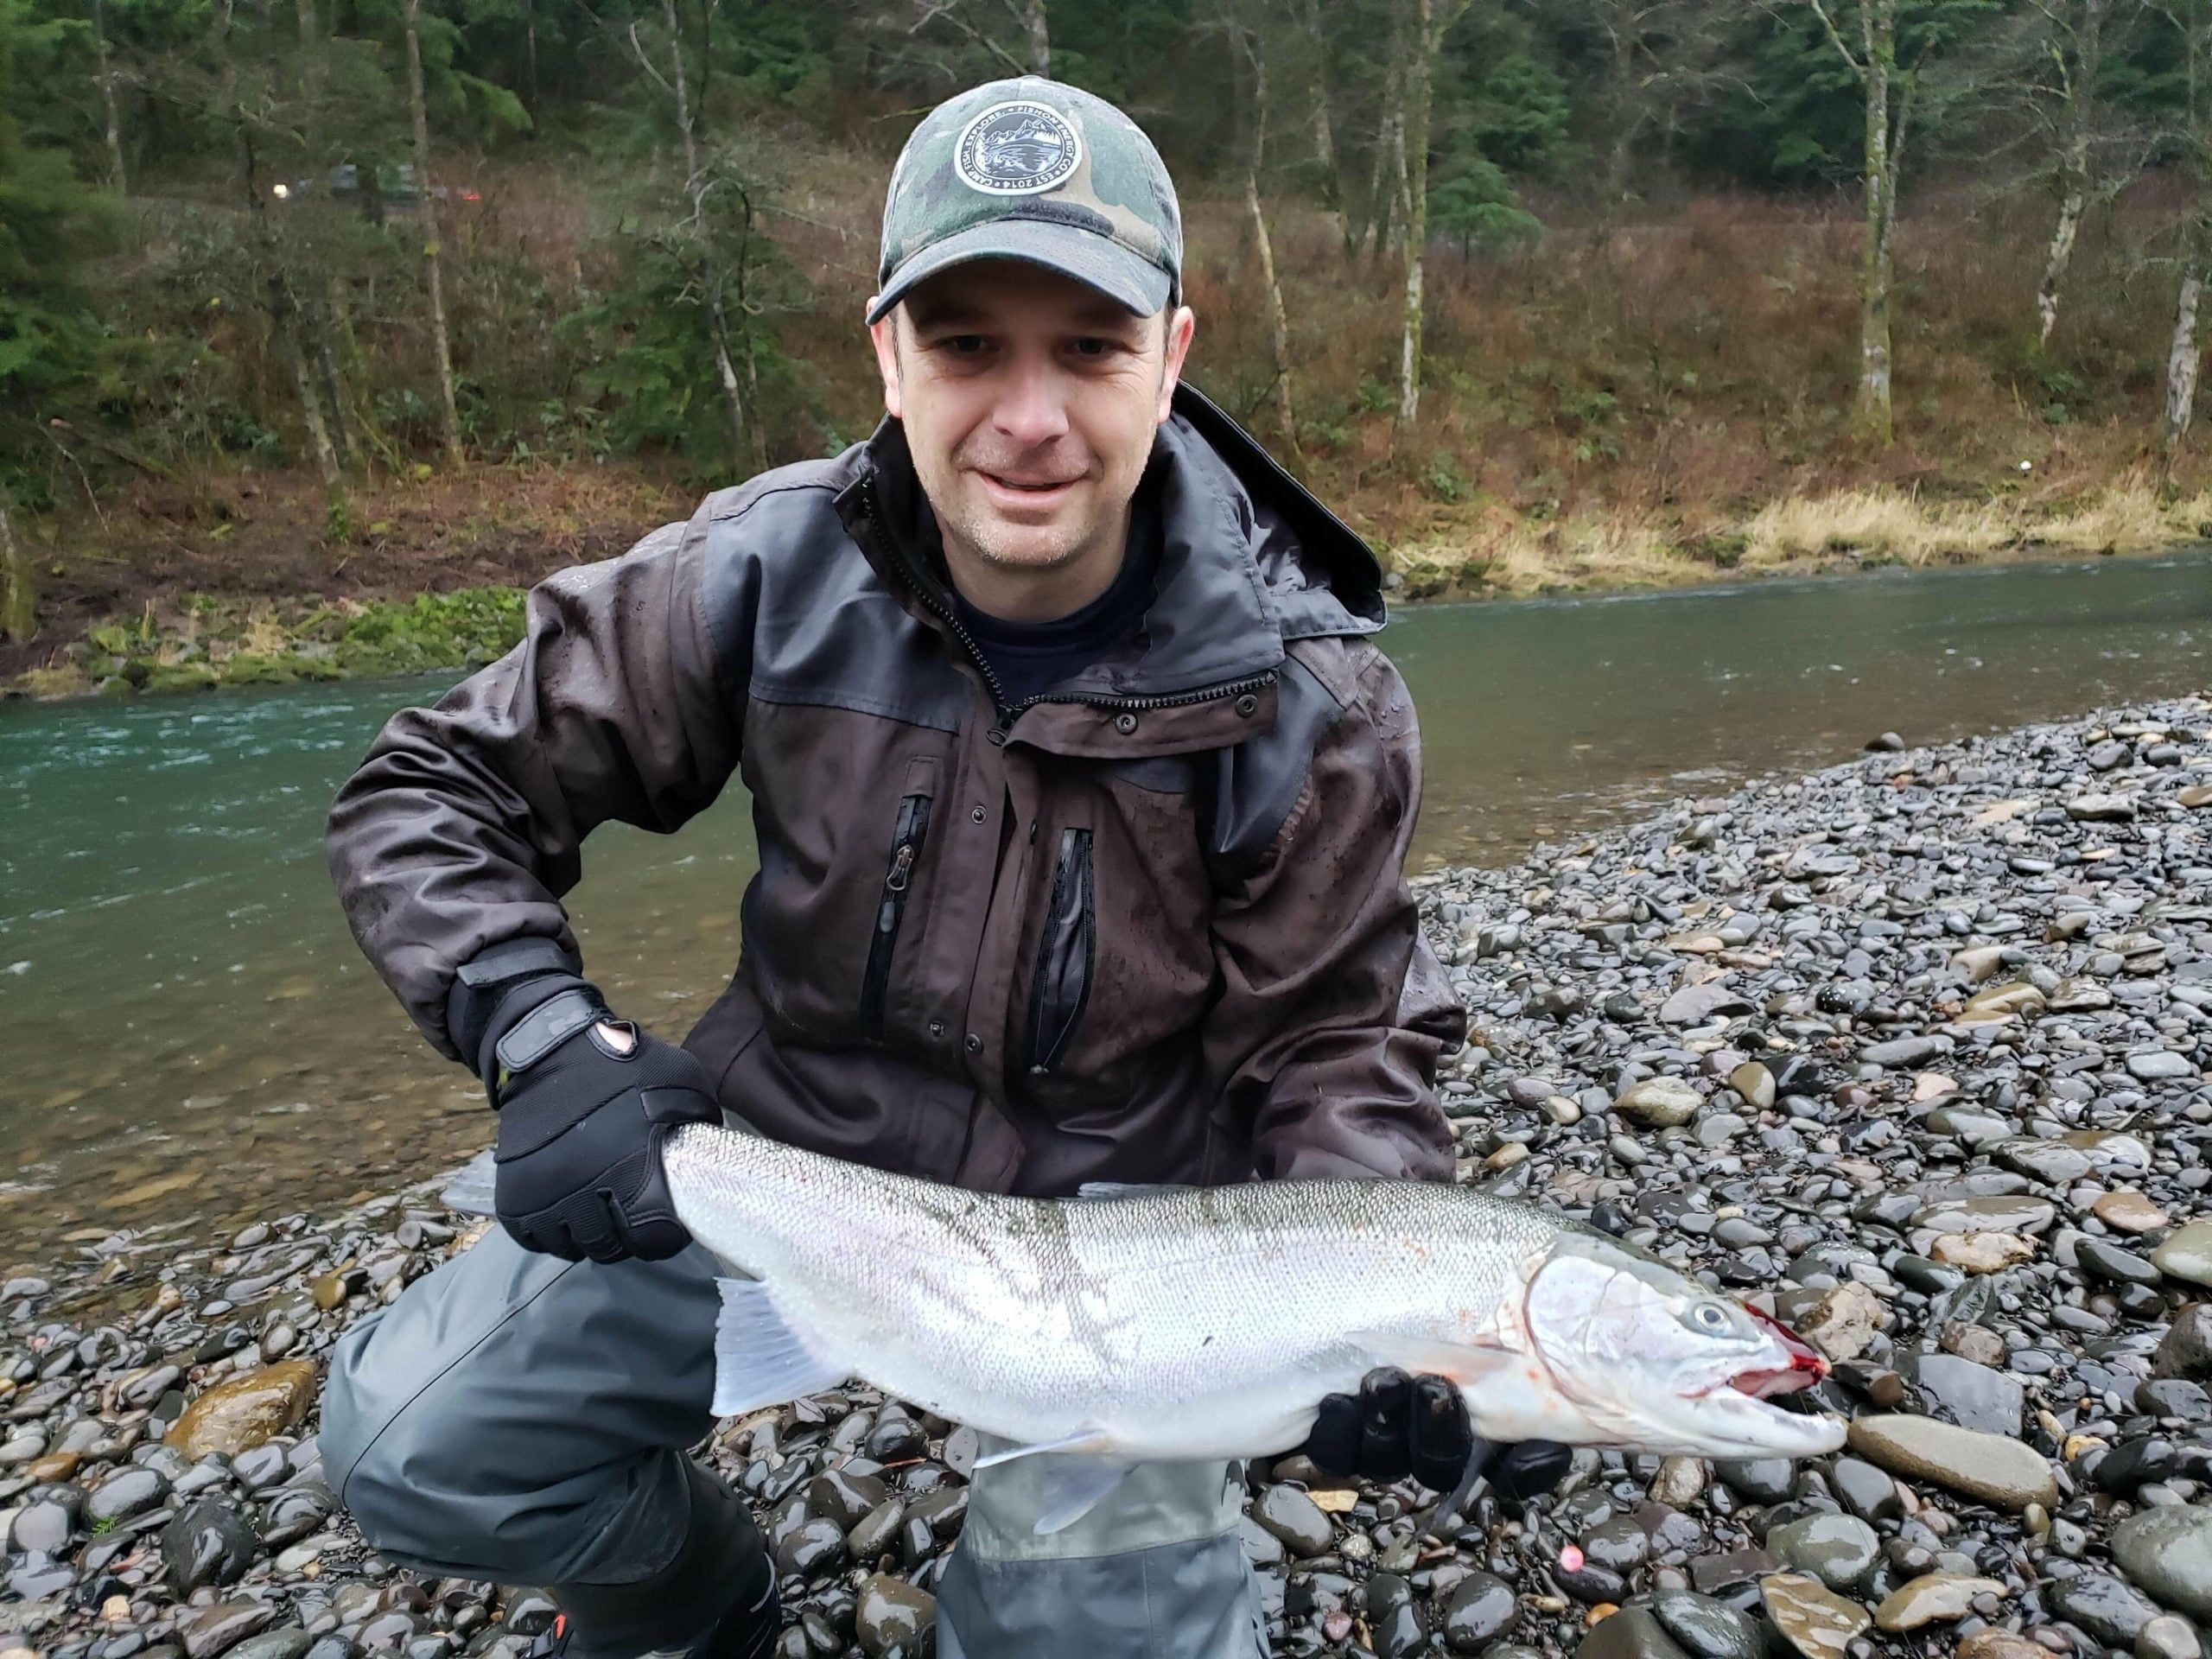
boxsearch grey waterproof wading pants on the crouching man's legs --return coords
[321,1228,1265,1659]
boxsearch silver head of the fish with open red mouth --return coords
[1466,1234,1842,1458]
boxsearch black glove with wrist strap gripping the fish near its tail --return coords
[460,955,721,1261]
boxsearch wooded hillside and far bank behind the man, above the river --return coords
[0,0,2212,695]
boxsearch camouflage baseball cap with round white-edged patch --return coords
[868,75,1184,323]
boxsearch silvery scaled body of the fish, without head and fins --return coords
[666,1128,1561,1458]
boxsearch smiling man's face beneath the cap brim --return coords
[869,259,1192,575]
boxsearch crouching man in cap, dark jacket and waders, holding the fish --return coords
[323,79,1555,1659]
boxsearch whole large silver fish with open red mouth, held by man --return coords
[440,1126,1842,1531]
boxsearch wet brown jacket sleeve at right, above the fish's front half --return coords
[1208,644,1465,1181]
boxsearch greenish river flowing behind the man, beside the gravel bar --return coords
[0,550,2212,1259]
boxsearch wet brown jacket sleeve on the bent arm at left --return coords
[325,500,750,1058]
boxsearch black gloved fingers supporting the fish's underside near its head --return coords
[1305,1365,1575,1502]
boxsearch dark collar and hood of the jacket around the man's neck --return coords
[838,385,1382,702]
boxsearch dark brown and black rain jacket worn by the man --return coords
[329,390,1462,1194]
